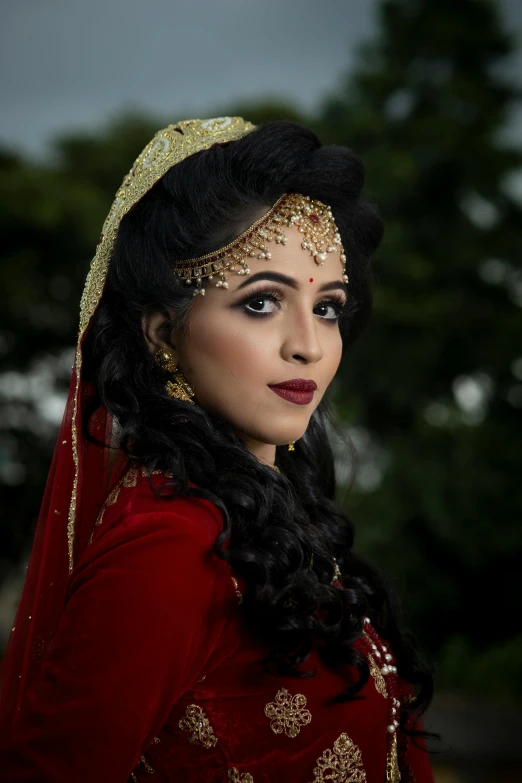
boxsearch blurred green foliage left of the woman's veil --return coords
[0,115,160,580]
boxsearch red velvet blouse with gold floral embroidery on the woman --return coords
[0,470,433,783]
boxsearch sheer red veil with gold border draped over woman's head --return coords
[0,117,254,737]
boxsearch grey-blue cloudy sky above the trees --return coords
[0,0,522,155]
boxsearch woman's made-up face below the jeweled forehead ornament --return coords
[169,220,347,464]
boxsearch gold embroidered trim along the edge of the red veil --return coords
[67,117,255,572]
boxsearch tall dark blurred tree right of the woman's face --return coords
[316,0,522,697]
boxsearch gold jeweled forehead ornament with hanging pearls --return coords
[174,193,348,296]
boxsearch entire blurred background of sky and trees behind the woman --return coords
[0,0,522,783]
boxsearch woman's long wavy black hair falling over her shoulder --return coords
[80,121,433,734]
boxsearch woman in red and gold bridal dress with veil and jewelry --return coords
[0,117,432,783]
